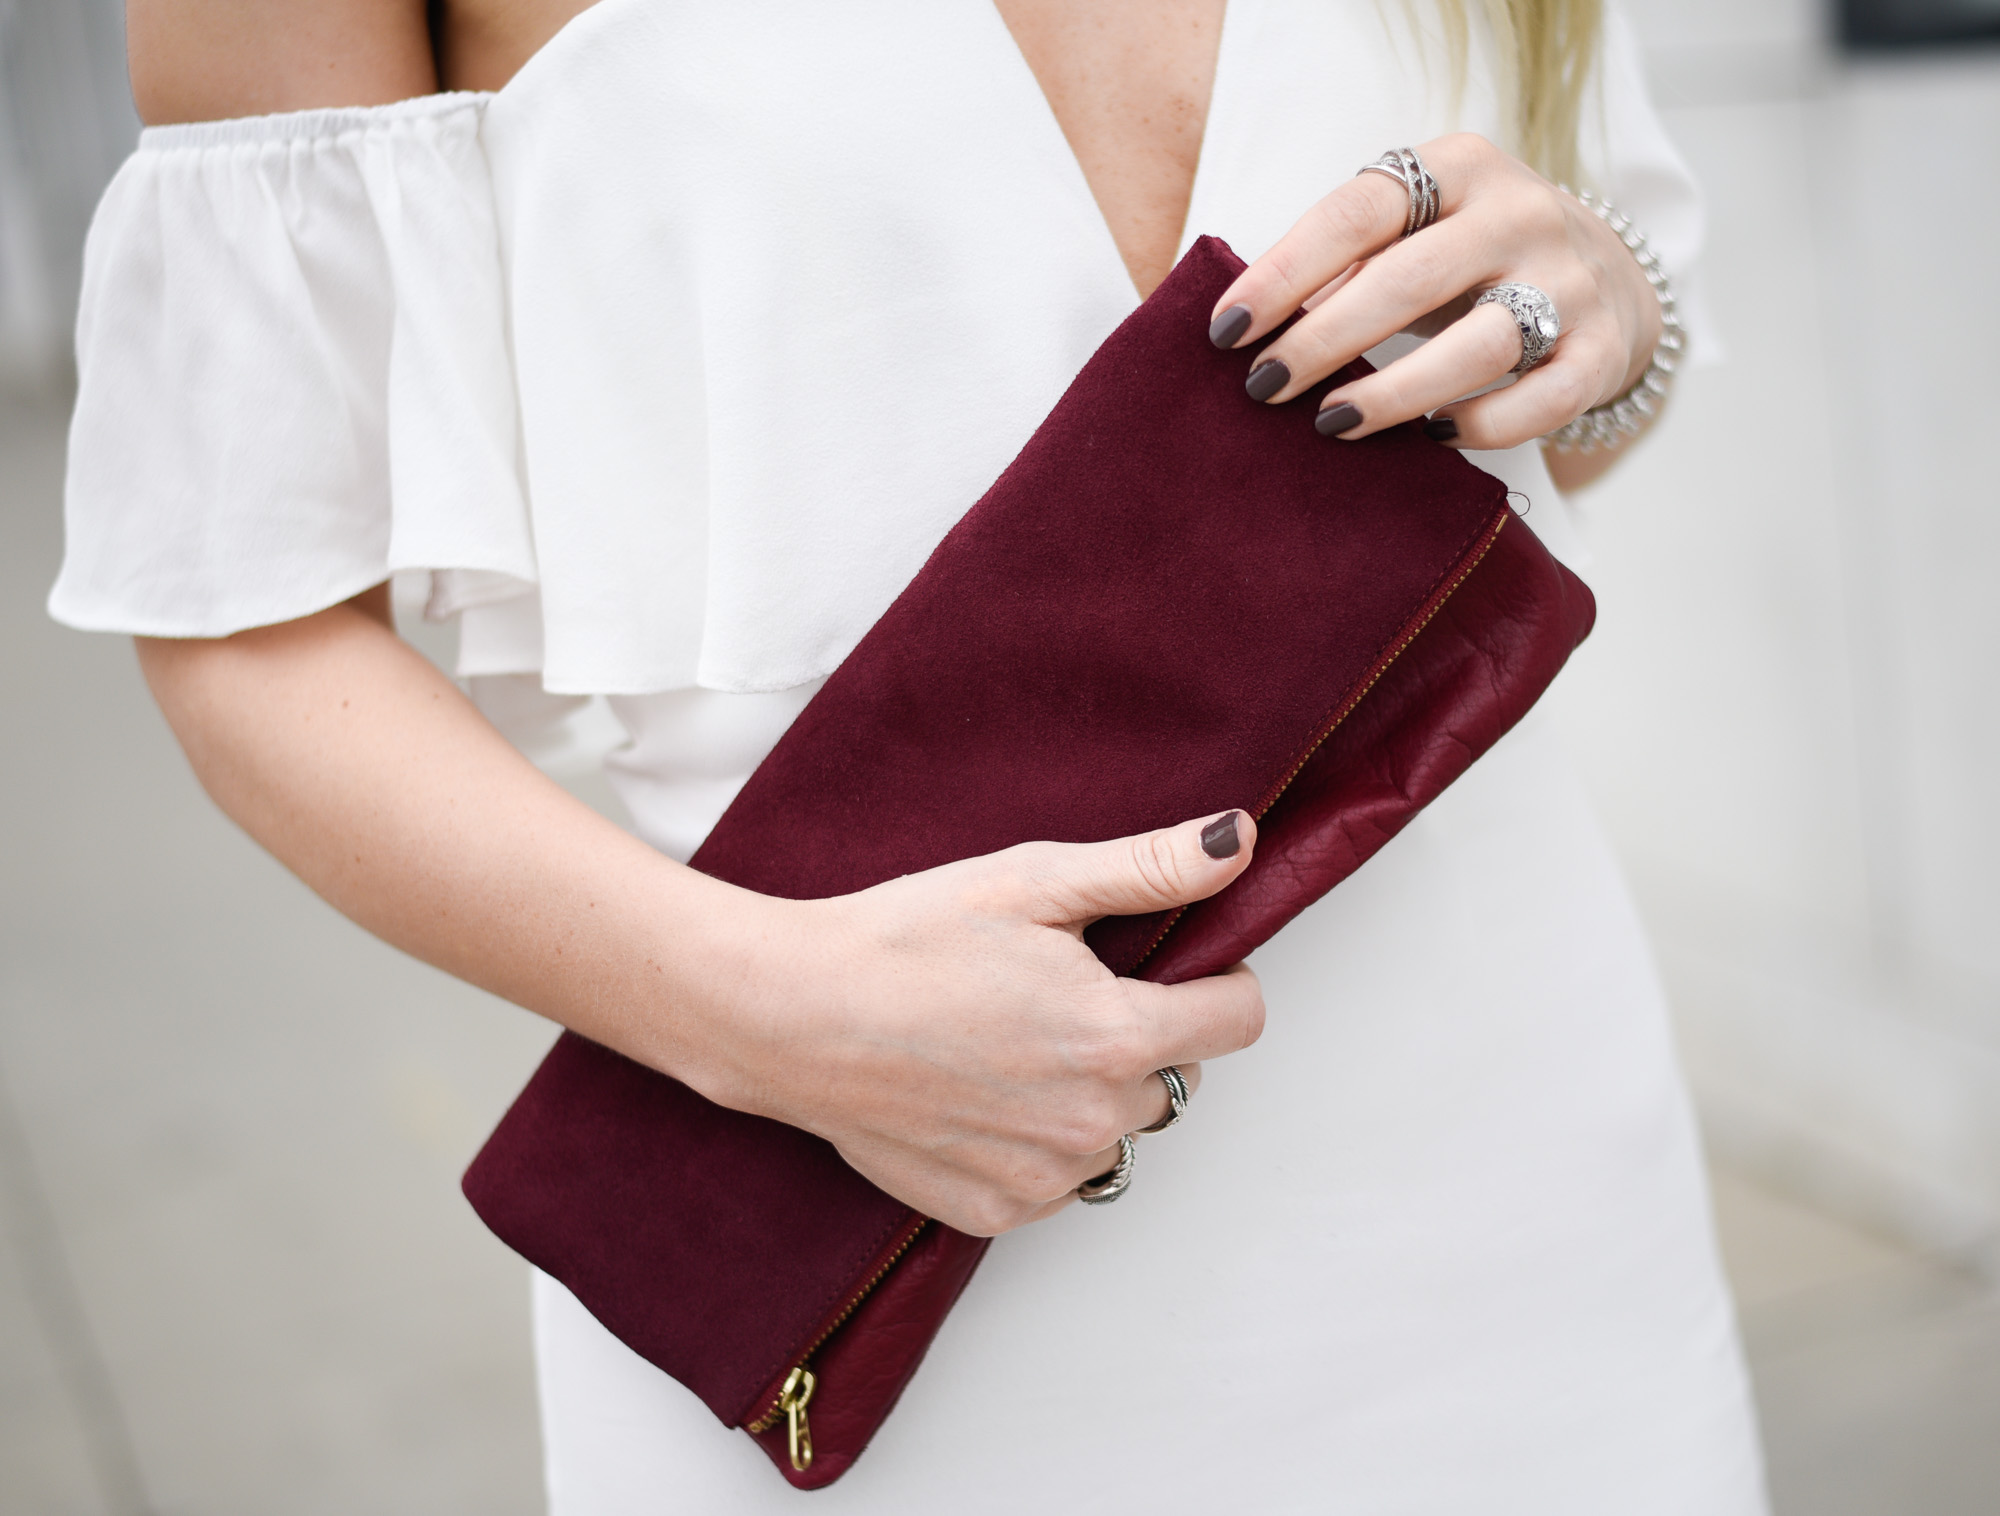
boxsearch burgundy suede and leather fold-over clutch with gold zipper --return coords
[464,238,1594,1488]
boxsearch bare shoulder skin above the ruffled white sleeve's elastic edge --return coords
[126,0,438,126]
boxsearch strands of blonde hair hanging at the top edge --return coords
[1438,0,1604,184]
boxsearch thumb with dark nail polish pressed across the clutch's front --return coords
[1040,810,1256,924]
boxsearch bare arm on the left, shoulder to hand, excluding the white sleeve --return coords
[117,0,1262,1232]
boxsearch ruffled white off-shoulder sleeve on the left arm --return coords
[50,94,536,636]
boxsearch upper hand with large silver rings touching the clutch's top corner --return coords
[1212,132,1660,448]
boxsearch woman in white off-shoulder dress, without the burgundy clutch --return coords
[52,0,1762,1516]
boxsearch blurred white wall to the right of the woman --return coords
[1560,0,2000,1256]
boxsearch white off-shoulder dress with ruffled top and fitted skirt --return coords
[50,0,1764,1516]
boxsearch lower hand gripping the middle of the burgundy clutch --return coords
[676,812,1264,1236]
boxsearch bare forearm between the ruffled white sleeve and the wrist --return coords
[140,592,764,1074]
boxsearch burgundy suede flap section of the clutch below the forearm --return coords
[464,1034,914,1426]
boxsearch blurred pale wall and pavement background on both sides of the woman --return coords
[0,0,2000,1516]
